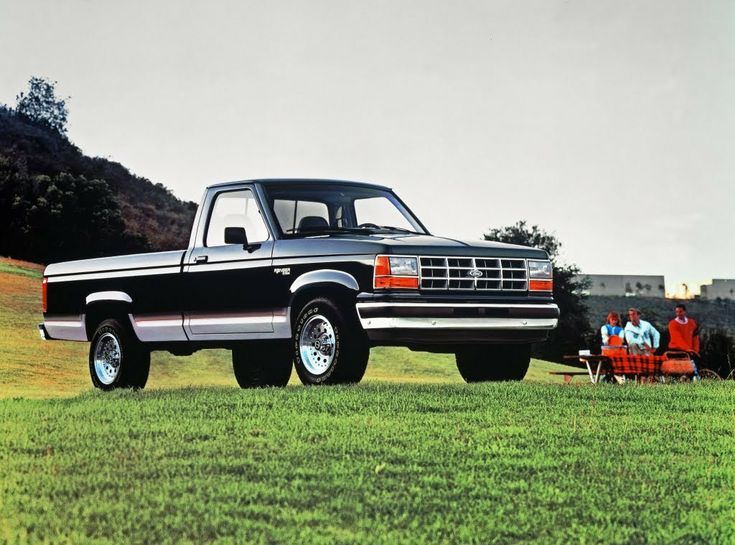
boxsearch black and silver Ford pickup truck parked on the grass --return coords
[38,180,559,390]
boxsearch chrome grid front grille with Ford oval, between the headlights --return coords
[419,256,528,291]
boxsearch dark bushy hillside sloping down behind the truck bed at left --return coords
[0,106,196,262]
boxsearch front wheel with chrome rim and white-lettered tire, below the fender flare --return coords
[292,298,370,385]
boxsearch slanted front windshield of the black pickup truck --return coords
[264,182,426,237]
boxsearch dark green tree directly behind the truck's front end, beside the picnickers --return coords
[484,221,592,361]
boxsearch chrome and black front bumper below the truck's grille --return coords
[357,302,559,344]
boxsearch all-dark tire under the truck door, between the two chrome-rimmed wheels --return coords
[232,341,293,388]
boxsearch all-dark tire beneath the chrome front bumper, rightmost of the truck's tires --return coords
[456,344,531,382]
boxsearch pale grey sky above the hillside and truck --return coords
[0,0,735,292]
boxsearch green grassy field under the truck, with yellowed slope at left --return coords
[0,260,735,544]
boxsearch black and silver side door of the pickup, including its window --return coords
[182,186,275,340]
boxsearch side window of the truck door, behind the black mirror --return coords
[204,189,269,246]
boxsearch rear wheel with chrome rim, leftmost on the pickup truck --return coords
[89,319,151,391]
